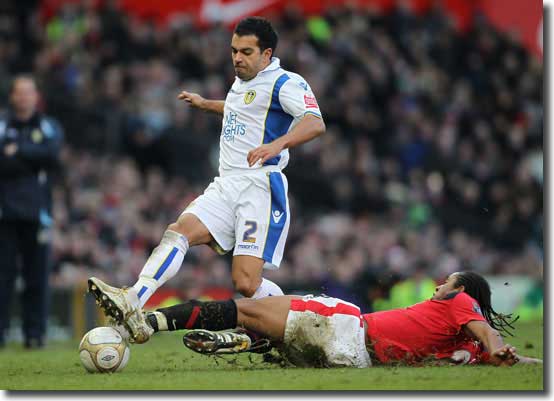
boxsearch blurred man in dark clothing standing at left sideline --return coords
[0,75,63,348]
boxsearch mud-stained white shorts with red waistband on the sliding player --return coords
[281,295,371,368]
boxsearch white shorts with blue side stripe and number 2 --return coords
[183,170,290,269]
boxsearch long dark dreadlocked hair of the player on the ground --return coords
[455,271,519,336]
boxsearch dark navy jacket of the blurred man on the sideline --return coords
[0,113,63,222]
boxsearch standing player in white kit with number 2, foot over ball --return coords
[89,17,325,343]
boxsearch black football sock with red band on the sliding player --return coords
[152,299,237,331]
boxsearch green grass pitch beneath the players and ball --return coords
[0,323,543,390]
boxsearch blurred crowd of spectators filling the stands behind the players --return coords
[0,1,544,309]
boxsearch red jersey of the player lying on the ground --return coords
[363,292,486,363]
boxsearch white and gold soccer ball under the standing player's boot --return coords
[79,327,131,373]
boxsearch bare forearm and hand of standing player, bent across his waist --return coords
[247,114,326,167]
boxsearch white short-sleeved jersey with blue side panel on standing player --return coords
[219,57,321,176]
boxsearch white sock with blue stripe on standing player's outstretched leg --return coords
[133,230,189,307]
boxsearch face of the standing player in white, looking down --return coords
[231,34,271,81]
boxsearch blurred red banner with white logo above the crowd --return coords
[42,0,543,58]
